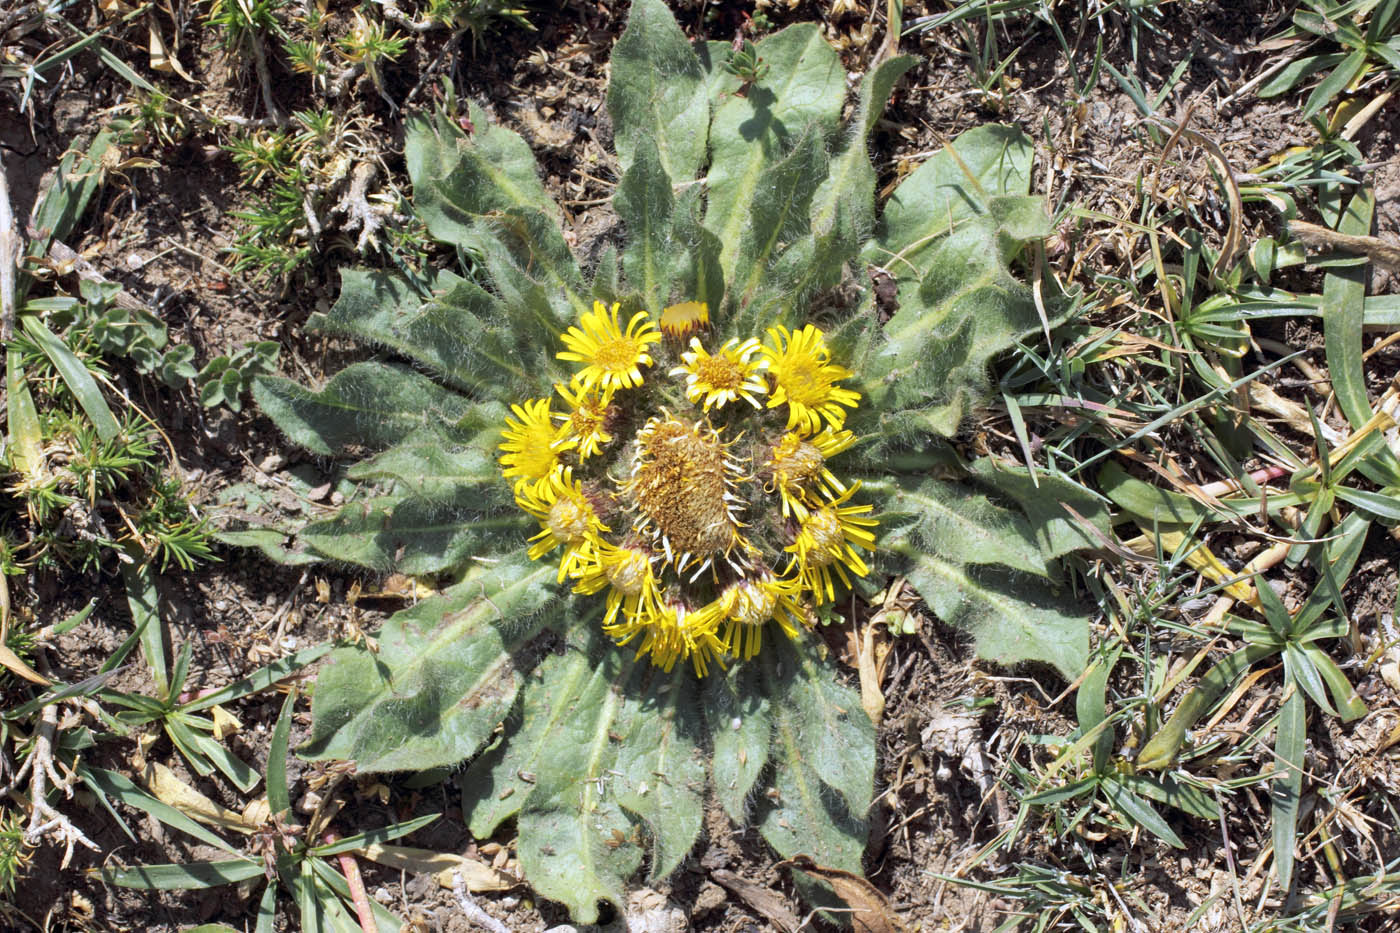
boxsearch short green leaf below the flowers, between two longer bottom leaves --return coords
[701,664,773,827]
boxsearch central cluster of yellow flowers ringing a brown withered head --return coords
[500,301,876,674]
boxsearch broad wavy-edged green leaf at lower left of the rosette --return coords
[300,552,556,773]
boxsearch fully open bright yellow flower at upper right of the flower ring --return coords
[763,324,861,434]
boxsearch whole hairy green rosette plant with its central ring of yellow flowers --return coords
[246,0,1103,922]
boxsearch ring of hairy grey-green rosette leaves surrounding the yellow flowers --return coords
[246,0,1105,922]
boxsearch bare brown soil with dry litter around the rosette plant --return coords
[0,0,1400,933]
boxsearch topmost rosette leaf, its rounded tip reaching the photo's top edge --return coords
[608,0,710,182]
